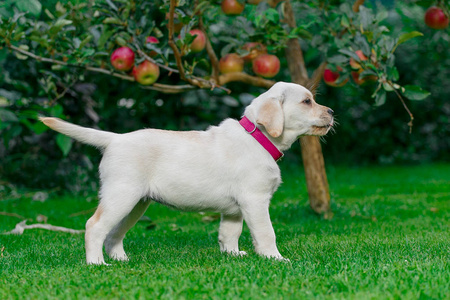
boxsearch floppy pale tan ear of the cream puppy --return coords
[256,97,284,138]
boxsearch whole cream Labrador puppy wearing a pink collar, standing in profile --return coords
[41,82,333,264]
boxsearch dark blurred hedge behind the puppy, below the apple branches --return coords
[0,1,450,193]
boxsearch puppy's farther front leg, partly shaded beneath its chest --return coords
[219,214,247,255]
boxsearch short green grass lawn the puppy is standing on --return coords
[0,162,450,299]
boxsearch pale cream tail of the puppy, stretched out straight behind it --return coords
[39,117,117,149]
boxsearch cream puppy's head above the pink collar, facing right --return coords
[245,82,334,138]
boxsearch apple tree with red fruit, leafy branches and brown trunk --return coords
[0,0,438,213]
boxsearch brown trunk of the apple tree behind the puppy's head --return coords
[284,1,330,214]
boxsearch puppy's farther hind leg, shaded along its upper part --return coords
[105,200,151,261]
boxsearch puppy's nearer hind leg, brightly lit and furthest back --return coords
[85,185,141,265]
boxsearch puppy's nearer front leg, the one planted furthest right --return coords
[242,202,284,260]
